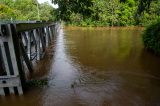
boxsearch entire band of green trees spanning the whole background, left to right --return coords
[0,0,160,26]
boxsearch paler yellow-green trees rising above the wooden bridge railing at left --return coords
[0,0,55,21]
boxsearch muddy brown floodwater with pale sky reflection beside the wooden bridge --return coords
[0,28,160,106]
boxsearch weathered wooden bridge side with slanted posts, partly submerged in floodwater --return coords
[0,22,59,95]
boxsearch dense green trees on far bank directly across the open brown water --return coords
[53,0,160,26]
